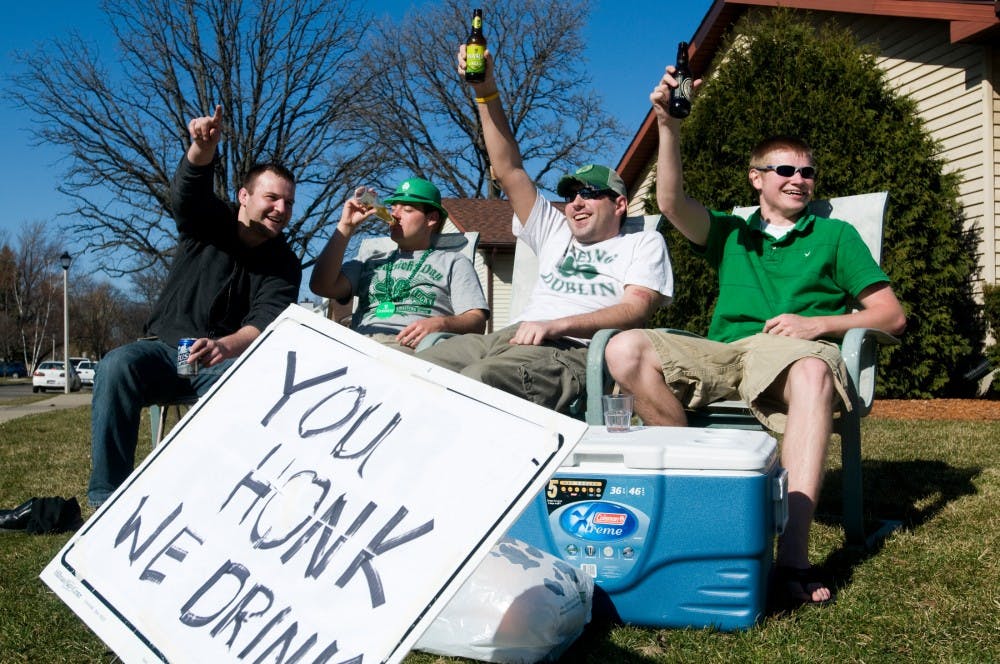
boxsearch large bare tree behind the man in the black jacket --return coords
[8,0,394,276]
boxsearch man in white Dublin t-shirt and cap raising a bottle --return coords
[417,46,673,411]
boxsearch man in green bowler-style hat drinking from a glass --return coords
[309,177,489,353]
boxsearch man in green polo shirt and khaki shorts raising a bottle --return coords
[606,67,906,605]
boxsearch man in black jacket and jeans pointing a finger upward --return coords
[87,106,302,507]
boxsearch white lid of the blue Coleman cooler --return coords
[563,426,777,471]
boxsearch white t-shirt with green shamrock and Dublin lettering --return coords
[512,195,674,343]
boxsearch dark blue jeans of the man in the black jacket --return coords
[87,340,233,507]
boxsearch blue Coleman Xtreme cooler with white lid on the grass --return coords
[509,426,788,630]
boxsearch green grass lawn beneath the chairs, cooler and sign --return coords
[0,407,1000,664]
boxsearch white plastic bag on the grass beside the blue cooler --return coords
[416,537,594,664]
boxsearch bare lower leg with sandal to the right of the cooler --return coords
[772,358,834,602]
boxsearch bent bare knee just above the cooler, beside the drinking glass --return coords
[604,330,687,426]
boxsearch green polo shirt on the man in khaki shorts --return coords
[694,210,889,342]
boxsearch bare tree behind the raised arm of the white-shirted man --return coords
[358,0,625,197]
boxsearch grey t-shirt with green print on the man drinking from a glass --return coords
[342,249,489,335]
